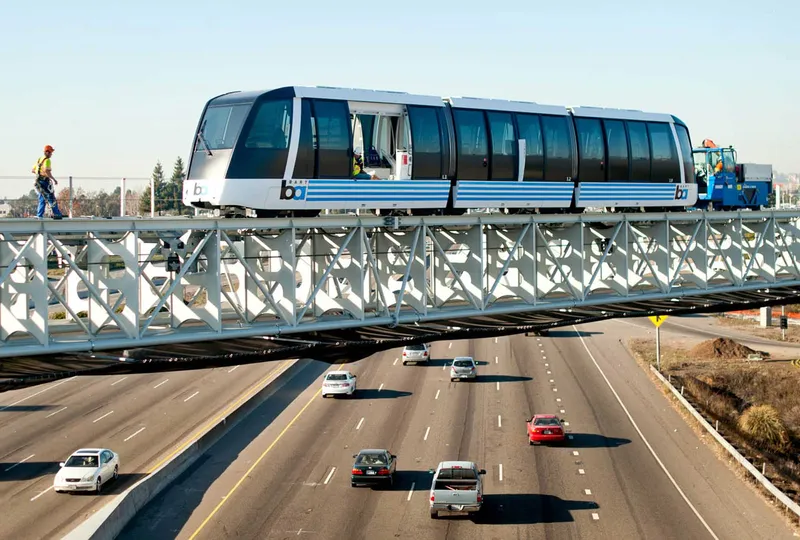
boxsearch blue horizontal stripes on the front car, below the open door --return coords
[305,179,450,204]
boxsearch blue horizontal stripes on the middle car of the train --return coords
[456,180,574,205]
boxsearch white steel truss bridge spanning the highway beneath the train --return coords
[0,211,800,384]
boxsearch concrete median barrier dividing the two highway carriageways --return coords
[63,359,313,540]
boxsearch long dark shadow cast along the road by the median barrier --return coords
[117,360,330,540]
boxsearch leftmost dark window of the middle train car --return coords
[453,109,489,180]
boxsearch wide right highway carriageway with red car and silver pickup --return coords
[120,321,793,540]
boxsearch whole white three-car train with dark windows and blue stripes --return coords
[183,86,697,217]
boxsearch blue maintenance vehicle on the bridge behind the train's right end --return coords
[692,139,773,210]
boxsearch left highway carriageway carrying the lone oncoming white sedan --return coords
[0,356,298,540]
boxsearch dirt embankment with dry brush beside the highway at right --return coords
[629,338,800,508]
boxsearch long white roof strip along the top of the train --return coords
[209,86,682,124]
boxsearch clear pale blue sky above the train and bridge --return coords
[0,0,800,196]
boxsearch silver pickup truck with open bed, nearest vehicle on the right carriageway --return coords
[429,461,486,519]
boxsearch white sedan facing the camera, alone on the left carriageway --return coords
[53,448,119,493]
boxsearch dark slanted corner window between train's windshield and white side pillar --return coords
[228,99,292,178]
